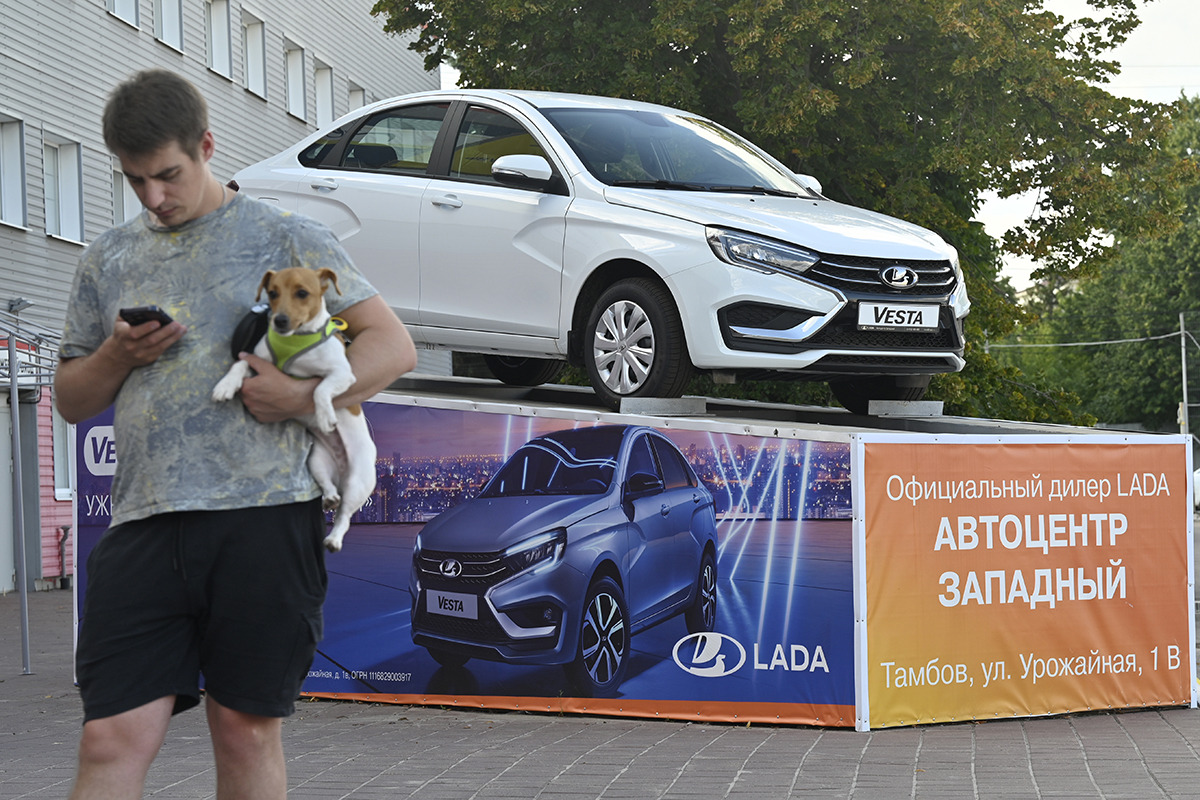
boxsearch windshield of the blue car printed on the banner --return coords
[479,426,624,498]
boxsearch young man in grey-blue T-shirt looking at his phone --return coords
[54,70,416,800]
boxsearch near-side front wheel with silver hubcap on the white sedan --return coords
[583,278,691,410]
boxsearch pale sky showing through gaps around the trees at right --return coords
[979,0,1200,289]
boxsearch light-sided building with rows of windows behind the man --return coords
[0,0,439,590]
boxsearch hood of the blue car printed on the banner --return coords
[421,494,608,553]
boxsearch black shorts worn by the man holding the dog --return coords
[76,498,328,722]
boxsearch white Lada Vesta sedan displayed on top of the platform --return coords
[235,90,970,413]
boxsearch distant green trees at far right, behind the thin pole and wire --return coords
[1002,97,1200,429]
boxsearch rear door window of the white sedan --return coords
[338,103,450,175]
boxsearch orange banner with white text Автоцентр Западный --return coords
[854,434,1195,729]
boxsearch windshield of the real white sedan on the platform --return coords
[541,108,810,197]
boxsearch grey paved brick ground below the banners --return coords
[0,591,1200,800]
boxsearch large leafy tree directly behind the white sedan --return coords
[374,0,1188,420]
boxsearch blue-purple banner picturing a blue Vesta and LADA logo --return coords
[79,395,854,727]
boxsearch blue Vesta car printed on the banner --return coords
[409,425,716,697]
